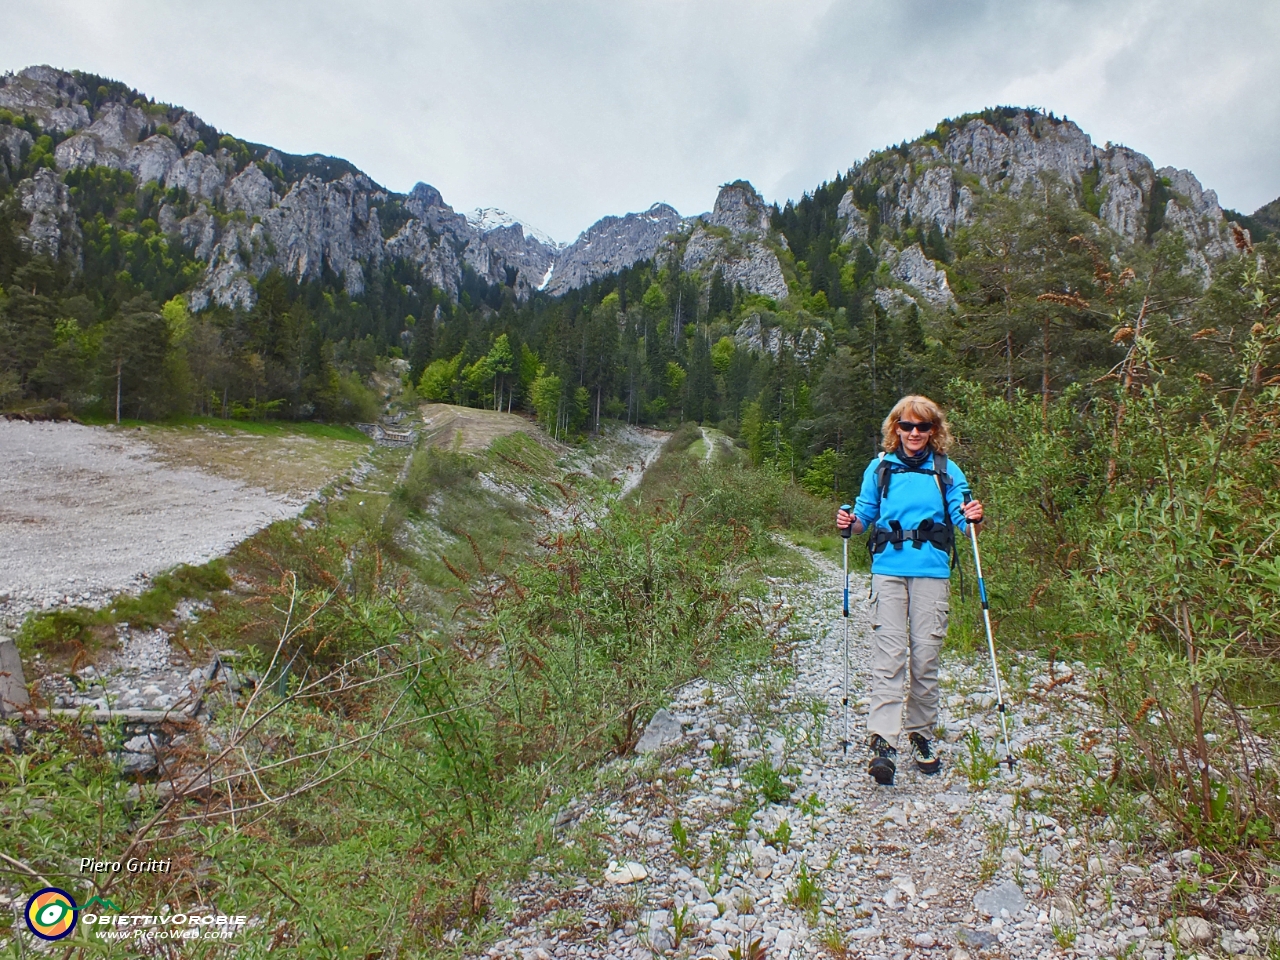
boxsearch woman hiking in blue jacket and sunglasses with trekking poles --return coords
[836,396,983,786]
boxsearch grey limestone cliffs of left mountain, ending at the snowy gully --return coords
[0,67,556,308]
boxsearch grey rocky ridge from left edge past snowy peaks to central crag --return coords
[0,67,787,308]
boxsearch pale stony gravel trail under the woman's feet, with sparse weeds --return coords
[486,550,1239,960]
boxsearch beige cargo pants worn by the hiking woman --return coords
[867,573,951,746]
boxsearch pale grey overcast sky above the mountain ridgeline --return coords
[0,0,1280,241]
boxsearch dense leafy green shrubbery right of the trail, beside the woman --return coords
[952,249,1280,849]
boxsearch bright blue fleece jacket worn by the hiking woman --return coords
[854,453,969,580]
